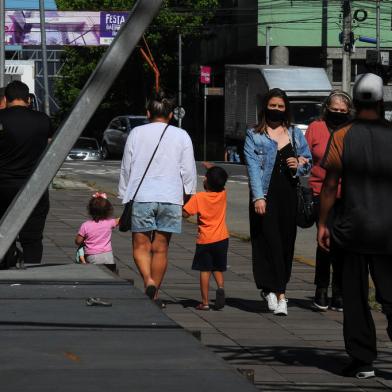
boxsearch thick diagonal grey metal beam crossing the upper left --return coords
[0,0,163,260]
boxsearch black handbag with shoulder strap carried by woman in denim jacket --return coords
[293,134,315,229]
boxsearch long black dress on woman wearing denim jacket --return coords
[249,143,298,293]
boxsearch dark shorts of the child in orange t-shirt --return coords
[192,238,229,272]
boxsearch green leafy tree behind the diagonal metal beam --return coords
[55,0,219,129]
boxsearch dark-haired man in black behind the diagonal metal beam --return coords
[0,81,52,268]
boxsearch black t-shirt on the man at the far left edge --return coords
[0,106,53,181]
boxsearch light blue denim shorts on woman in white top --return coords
[132,202,182,233]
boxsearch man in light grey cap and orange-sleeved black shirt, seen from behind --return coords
[318,74,392,378]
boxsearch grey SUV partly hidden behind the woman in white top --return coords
[101,115,148,159]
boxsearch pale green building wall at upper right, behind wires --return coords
[258,0,392,48]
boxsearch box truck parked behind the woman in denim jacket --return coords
[225,65,332,139]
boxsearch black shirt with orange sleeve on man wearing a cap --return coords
[324,120,392,255]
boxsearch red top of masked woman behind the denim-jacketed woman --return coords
[305,120,340,197]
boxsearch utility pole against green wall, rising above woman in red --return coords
[342,0,352,94]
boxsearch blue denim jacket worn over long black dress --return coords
[244,127,312,200]
